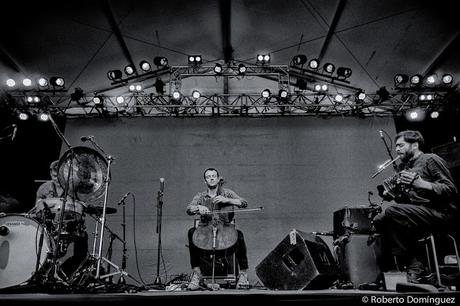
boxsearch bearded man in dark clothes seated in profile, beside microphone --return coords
[372,131,458,283]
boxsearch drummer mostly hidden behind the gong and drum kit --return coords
[35,160,88,276]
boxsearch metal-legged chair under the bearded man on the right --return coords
[419,233,460,287]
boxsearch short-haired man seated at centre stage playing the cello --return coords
[187,168,249,290]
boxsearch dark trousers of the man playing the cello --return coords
[188,227,248,270]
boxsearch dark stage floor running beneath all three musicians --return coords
[0,289,460,306]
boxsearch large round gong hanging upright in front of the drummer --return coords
[58,147,107,202]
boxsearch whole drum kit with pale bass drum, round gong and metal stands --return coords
[0,142,136,291]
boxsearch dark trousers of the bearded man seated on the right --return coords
[372,204,452,271]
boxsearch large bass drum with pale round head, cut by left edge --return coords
[0,214,53,289]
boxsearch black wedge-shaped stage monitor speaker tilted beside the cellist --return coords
[256,229,338,290]
